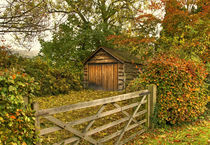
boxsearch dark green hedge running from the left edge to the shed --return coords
[0,47,82,96]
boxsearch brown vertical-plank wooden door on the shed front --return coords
[88,64,118,91]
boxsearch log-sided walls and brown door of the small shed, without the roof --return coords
[84,50,140,90]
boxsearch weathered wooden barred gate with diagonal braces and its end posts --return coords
[34,85,156,145]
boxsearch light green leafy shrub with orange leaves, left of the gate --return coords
[0,70,37,144]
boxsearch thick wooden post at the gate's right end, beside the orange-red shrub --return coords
[148,84,157,128]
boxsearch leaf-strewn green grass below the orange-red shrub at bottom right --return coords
[133,120,210,145]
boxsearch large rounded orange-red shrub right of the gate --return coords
[127,55,208,125]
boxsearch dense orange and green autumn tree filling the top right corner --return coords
[157,0,209,63]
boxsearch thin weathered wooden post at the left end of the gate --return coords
[33,102,41,145]
